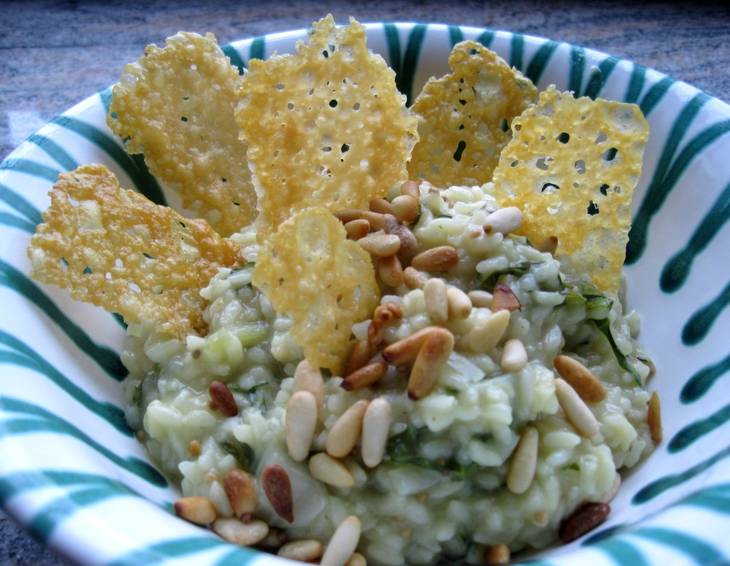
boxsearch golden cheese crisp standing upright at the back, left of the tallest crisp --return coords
[107,32,256,236]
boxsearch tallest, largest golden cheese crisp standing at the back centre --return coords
[236,16,417,241]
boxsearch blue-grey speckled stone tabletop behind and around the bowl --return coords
[0,0,730,566]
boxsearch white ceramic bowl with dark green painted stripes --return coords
[0,23,730,565]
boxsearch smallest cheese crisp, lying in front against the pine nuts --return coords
[253,207,380,372]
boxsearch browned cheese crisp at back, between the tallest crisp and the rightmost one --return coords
[408,41,537,187]
